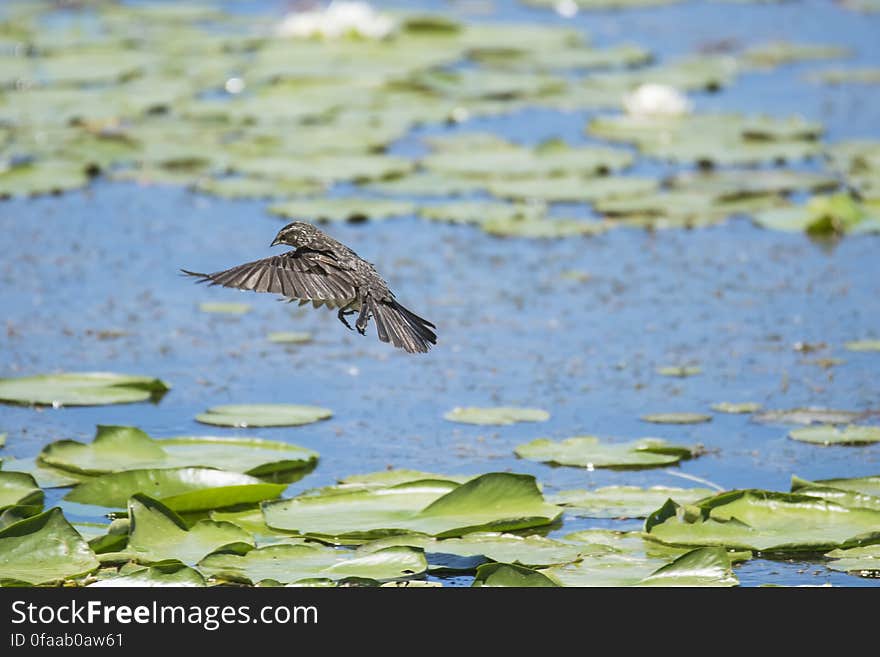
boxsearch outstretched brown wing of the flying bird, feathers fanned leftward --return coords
[181,249,357,307]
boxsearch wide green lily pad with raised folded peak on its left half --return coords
[39,426,318,476]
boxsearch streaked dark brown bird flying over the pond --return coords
[181,221,437,353]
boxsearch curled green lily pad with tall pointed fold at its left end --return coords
[123,493,254,565]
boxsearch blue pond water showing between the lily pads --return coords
[0,1,880,586]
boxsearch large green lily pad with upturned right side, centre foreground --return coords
[263,472,561,541]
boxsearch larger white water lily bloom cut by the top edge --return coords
[276,2,395,39]
